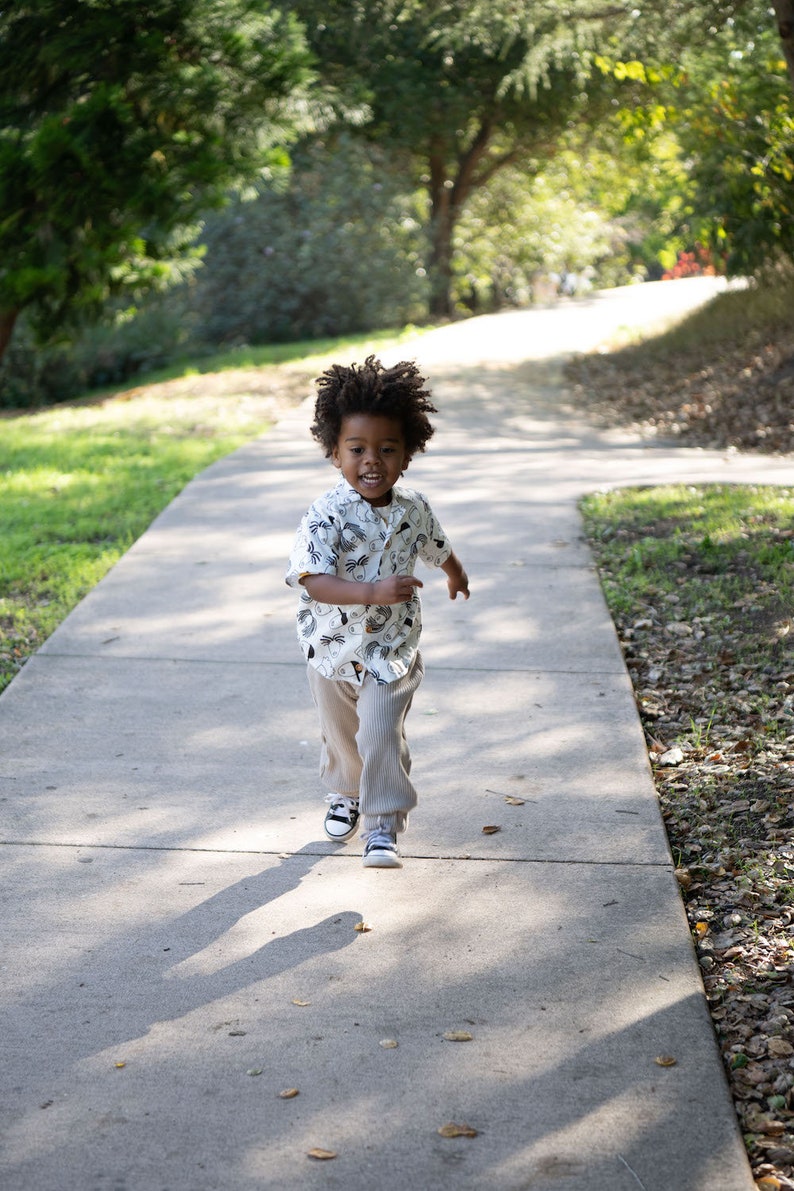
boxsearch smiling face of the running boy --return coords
[331,413,411,507]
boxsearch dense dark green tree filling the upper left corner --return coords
[0,0,311,358]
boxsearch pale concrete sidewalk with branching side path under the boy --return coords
[0,287,794,1191]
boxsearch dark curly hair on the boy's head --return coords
[312,356,438,457]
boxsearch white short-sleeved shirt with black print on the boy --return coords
[287,478,452,682]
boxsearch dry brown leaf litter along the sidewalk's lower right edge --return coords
[586,481,794,1191]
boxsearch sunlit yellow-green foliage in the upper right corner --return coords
[598,2,794,275]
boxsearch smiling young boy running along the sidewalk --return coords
[287,356,469,868]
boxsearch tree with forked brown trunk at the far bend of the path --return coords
[295,0,630,316]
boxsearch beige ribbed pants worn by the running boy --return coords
[308,654,425,831]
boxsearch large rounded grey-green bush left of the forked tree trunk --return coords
[188,136,426,344]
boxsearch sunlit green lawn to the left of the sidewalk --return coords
[0,329,428,691]
